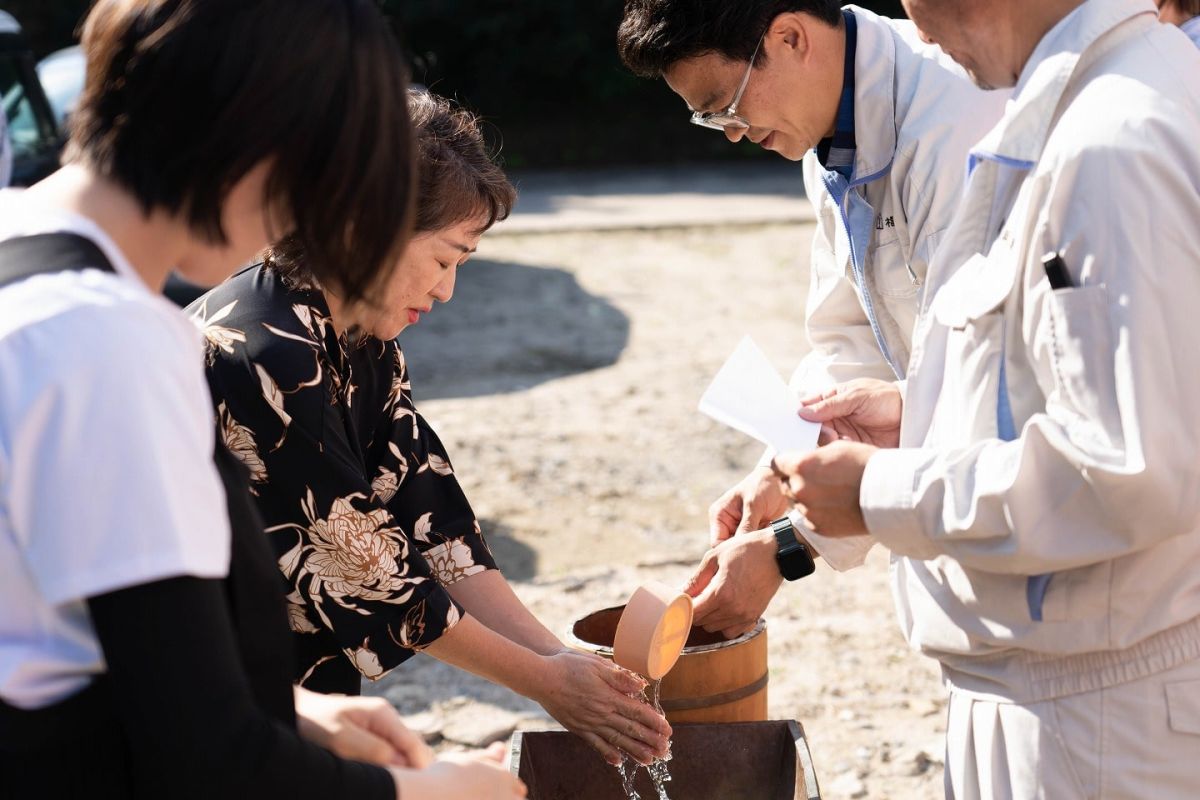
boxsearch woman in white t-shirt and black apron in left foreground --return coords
[0,0,524,800]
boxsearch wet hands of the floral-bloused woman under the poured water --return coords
[533,649,671,765]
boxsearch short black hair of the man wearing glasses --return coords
[617,0,841,78]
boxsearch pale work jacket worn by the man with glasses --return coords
[791,6,1008,392]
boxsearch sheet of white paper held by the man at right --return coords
[700,336,821,452]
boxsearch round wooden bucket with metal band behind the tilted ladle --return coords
[568,606,768,724]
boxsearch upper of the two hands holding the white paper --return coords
[799,378,904,447]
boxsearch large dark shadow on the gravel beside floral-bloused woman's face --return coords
[400,260,629,403]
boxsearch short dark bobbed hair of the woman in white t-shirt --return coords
[72,0,414,300]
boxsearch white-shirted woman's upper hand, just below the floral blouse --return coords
[295,686,433,769]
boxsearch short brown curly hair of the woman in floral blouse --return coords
[264,90,516,288]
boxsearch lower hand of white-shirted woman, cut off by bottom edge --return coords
[391,742,526,800]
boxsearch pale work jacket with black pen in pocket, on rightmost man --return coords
[860,0,1200,702]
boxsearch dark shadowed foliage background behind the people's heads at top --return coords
[9,0,904,167]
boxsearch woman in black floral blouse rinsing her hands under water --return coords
[191,92,670,763]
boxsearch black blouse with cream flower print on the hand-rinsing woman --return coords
[188,266,496,693]
